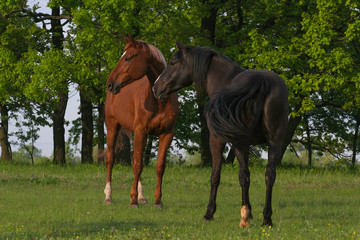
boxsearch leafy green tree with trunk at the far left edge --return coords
[0,1,44,161]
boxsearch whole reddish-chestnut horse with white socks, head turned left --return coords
[104,36,178,208]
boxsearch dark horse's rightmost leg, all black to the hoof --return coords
[263,142,281,226]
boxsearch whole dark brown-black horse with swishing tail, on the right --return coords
[153,43,288,226]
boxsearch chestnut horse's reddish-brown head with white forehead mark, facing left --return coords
[106,36,148,94]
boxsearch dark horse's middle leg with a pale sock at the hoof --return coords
[235,149,252,227]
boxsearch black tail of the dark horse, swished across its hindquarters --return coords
[205,77,268,148]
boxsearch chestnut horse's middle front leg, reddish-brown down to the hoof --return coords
[130,129,147,207]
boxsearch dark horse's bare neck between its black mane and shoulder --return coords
[206,56,240,96]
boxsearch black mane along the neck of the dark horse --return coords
[186,46,244,94]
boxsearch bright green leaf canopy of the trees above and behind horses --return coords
[0,0,360,163]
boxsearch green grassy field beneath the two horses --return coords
[0,163,360,239]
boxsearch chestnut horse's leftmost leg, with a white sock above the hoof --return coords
[104,122,119,204]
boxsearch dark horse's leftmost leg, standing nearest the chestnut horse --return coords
[204,130,225,221]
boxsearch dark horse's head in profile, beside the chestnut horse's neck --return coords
[153,42,193,98]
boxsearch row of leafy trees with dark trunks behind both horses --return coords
[0,0,360,165]
